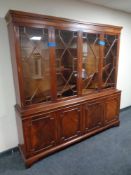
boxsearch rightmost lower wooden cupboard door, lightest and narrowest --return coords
[105,96,120,124]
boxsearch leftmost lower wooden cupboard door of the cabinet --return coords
[31,113,57,153]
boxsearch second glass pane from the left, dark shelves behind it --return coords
[55,30,77,98]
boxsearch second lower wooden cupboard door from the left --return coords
[59,106,82,142]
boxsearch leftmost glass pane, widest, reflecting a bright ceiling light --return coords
[19,27,51,105]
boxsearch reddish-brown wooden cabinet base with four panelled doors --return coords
[17,91,120,166]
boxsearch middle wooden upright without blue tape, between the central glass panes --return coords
[77,31,83,96]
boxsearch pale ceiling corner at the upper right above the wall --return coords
[79,0,131,13]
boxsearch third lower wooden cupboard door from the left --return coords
[84,102,104,132]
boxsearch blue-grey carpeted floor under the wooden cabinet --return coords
[0,108,131,175]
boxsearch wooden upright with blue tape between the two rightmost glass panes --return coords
[98,34,105,90]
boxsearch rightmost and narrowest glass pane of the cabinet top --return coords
[103,35,118,88]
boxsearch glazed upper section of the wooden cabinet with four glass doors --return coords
[6,10,122,108]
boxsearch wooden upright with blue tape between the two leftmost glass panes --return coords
[48,27,57,101]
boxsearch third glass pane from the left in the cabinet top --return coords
[82,33,99,94]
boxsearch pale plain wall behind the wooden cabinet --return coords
[0,0,131,152]
